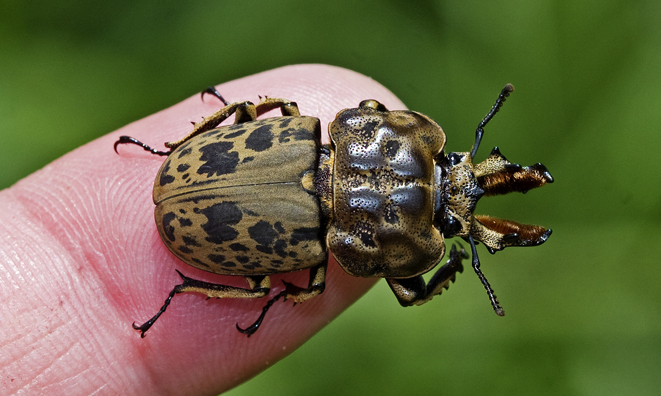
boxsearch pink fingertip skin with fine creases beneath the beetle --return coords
[0,65,405,395]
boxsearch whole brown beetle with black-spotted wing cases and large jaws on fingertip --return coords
[114,84,553,337]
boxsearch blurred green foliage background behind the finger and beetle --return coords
[0,0,661,396]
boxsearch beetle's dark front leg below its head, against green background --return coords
[386,245,468,307]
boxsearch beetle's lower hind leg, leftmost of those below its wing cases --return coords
[133,271,271,338]
